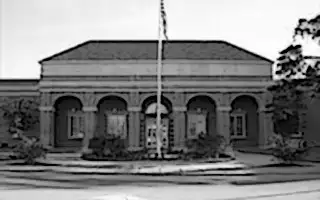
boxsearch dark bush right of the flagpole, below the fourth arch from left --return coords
[182,134,230,159]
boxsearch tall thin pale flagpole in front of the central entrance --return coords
[156,0,162,158]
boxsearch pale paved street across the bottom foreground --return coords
[0,173,320,200]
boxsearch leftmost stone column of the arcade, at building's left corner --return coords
[39,106,54,147]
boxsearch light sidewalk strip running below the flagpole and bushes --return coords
[0,161,251,175]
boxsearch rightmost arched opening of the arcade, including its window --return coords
[230,95,259,147]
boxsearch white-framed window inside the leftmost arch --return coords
[67,111,84,140]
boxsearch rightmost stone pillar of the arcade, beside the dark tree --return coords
[259,107,273,148]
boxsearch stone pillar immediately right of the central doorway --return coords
[173,107,187,151]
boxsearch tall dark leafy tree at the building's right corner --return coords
[268,15,320,134]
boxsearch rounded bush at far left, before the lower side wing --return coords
[13,138,48,165]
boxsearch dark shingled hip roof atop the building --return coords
[40,40,272,63]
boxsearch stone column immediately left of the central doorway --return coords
[128,107,141,151]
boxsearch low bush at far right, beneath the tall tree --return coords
[268,134,310,164]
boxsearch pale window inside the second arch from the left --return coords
[105,112,127,139]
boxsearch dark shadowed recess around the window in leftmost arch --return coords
[54,95,83,147]
